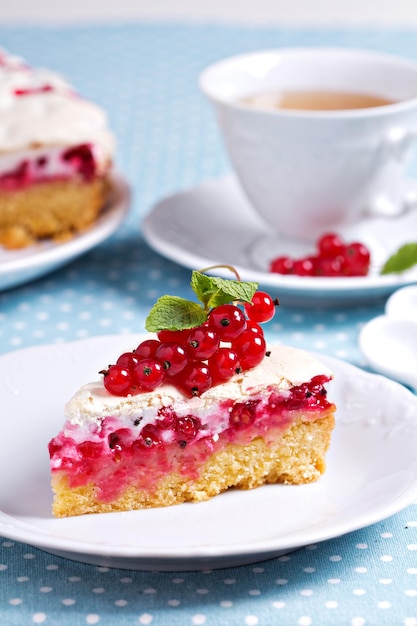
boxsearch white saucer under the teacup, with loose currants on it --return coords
[143,176,417,306]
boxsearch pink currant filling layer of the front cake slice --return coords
[49,376,332,502]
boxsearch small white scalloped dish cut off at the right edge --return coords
[359,285,417,391]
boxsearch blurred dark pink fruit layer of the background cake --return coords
[0,144,98,191]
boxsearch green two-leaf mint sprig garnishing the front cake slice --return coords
[145,271,258,333]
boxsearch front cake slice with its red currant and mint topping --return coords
[49,272,335,517]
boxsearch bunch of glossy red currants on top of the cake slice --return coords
[100,291,278,397]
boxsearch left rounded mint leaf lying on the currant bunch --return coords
[145,296,207,333]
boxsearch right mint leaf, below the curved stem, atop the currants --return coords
[191,272,258,309]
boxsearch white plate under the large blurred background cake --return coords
[0,174,130,291]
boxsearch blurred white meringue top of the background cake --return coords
[0,50,115,163]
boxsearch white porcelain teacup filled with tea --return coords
[200,48,417,240]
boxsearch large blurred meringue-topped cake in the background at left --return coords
[0,50,114,248]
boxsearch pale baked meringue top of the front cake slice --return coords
[65,346,331,428]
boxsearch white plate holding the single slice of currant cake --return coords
[0,336,417,571]
